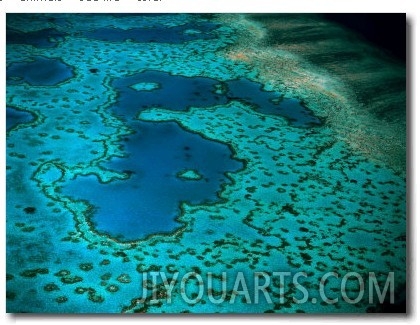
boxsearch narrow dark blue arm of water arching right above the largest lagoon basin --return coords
[113,71,321,127]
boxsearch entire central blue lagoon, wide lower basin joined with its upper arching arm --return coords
[63,71,317,241]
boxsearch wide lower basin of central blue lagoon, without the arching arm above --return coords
[63,122,242,241]
